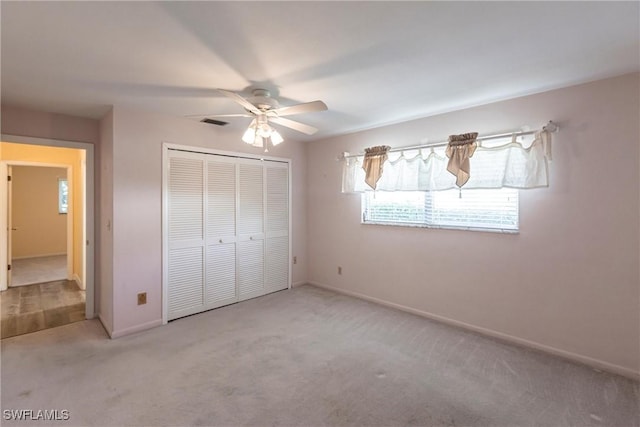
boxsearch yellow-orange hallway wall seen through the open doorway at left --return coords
[0,142,85,285]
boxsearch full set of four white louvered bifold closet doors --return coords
[163,148,290,321]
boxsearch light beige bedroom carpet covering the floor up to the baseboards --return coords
[1,286,640,427]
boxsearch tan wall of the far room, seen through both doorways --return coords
[11,166,67,259]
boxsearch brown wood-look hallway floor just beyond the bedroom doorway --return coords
[0,280,85,338]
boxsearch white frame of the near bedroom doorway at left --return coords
[0,134,95,319]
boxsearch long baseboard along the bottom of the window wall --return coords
[307,282,640,380]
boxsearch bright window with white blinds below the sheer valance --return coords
[362,188,519,233]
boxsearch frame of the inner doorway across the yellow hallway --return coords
[0,160,77,291]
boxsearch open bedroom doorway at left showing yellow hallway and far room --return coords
[0,135,94,338]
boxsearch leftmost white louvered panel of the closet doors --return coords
[167,152,204,320]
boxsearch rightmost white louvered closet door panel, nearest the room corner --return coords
[265,162,289,293]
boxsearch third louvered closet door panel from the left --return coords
[237,159,264,301]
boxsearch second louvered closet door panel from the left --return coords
[205,156,238,309]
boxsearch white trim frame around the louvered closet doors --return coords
[162,142,293,325]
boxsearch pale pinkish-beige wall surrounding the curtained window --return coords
[307,74,640,375]
